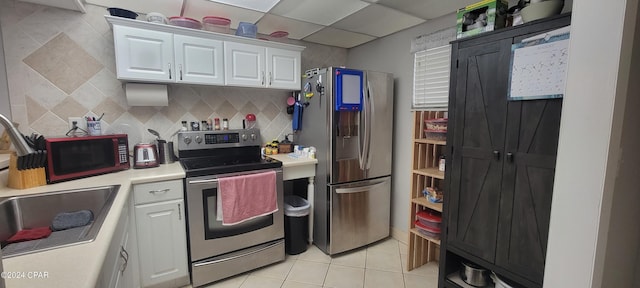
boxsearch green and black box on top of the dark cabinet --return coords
[456,0,509,39]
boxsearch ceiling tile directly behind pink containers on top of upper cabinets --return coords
[184,0,264,29]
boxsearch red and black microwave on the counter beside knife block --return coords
[46,134,131,183]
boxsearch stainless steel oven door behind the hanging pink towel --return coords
[185,168,284,262]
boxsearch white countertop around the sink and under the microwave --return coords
[0,163,185,288]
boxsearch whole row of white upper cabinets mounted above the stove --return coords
[105,15,304,90]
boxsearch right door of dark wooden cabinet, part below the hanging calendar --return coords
[496,99,562,284]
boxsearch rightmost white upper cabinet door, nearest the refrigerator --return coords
[267,48,301,90]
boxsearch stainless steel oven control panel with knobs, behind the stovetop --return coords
[178,129,260,151]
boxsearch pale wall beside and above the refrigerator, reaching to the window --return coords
[347,14,456,241]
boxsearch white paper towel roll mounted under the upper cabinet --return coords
[125,83,169,106]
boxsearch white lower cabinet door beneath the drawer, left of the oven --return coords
[135,200,188,287]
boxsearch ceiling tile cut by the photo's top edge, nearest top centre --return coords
[270,0,369,25]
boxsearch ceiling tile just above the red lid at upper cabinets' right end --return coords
[257,14,323,40]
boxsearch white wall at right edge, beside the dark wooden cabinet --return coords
[544,0,640,287]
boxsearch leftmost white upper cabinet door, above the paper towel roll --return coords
[113,25,175,82]
